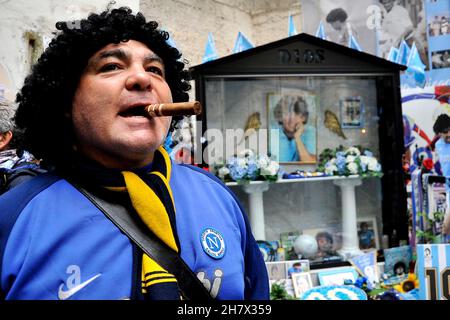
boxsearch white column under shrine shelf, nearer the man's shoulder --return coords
[242,182,269,240]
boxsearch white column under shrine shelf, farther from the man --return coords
[333,178,363,259]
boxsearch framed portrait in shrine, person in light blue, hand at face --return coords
[267,89,318,164]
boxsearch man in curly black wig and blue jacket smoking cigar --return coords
[0,8,269,300]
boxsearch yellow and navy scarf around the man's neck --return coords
[72,147,180,300]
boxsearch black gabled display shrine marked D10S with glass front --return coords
[191,34,408,263]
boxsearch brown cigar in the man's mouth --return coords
[145,101,202,117]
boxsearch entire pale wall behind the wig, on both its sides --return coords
[0,0,302,99]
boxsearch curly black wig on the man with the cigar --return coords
[15,7,191,168]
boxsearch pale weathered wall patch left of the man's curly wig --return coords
[0,0,139,100]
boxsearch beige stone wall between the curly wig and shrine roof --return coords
[140,0,301,66]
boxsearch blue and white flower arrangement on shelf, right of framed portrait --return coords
[318,146,383,177]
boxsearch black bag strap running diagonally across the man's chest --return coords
[73,184,213,301]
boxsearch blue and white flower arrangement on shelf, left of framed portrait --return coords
[213,149,280,182]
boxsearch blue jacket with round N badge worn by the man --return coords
[0,165,269,300]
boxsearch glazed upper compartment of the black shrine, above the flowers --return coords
[204,74,380,165]
